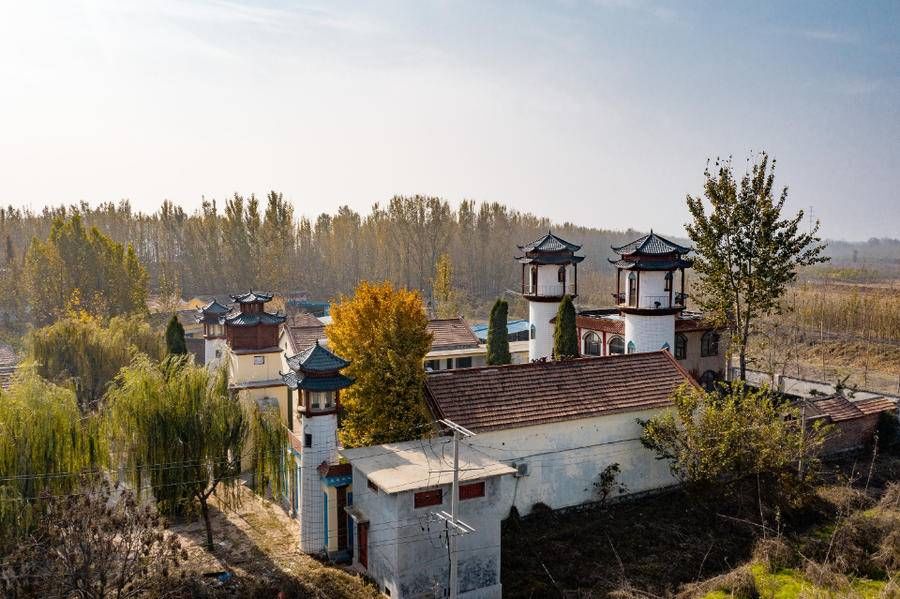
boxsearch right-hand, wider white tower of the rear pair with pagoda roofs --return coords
[610,231,693,353]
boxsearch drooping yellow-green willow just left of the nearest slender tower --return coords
[106,356,287,546]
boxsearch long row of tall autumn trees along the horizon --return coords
[0,191,638,322]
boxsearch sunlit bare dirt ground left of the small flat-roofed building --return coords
[170,489,379,599]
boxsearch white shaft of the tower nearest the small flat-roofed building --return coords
[297,414,338,553]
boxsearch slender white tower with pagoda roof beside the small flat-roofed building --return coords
[282,341,353,553]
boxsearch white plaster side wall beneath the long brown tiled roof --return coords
[478,409,676,515]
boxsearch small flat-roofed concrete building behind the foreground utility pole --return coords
[340,436,515,599]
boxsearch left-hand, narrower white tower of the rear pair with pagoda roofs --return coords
[516,232,584,360]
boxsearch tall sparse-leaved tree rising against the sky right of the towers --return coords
[685,152,828,380]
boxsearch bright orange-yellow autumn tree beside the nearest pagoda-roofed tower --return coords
[325,281,431,447]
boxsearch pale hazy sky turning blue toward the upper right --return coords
[0,0,900,239]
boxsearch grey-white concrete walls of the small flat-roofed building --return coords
[353,469,509,599]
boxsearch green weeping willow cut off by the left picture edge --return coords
[0,367,108,551]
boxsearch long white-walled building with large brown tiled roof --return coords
[426,351,696,515]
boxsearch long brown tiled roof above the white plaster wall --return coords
[426,351,697,432]
